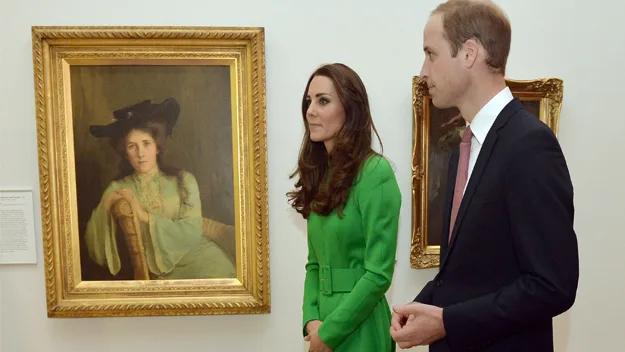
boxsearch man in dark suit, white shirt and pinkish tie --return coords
[391,0,579,352]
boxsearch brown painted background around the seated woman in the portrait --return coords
[70,66,234,280]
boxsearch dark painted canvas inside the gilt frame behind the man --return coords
[426,100,540,246]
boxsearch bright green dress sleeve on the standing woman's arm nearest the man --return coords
[318,158,401,350]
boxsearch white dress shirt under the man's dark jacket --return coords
[464,87,514,191]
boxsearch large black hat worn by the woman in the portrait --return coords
[89,98,180,138]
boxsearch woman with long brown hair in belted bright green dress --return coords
[288,64,401,352]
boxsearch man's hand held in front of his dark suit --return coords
[391,302,446,348]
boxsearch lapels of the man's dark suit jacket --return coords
[441,98,523,269]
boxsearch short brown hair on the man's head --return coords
[432,0,512,75]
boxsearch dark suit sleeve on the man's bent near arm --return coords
[443,127,579,349]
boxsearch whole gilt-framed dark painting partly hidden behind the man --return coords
[410,76,563,269]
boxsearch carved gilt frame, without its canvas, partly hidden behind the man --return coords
[410,76,563,269]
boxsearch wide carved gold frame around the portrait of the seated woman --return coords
[32,27,270,317]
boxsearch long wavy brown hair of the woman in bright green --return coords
[287,63,382,219]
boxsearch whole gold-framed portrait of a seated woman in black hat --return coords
[32,27,270,317]
